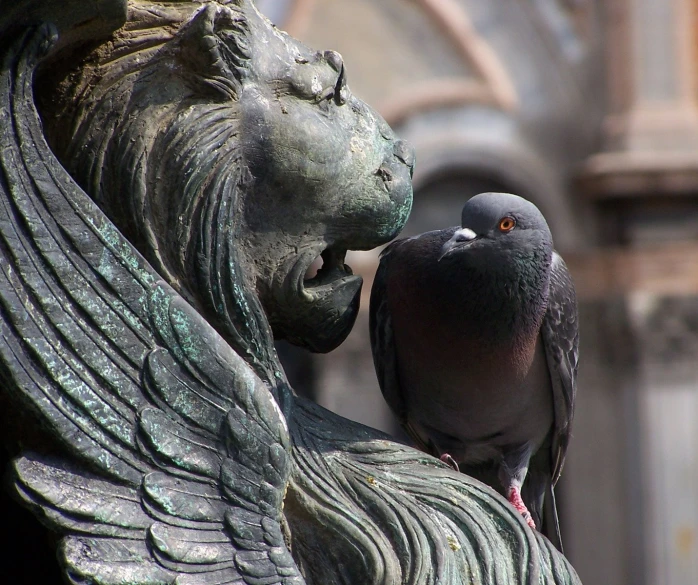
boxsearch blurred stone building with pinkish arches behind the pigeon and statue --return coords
[258,0,698,585]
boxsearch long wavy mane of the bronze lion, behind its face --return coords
[37,1,280,381]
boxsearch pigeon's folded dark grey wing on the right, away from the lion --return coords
[541,252,579,485]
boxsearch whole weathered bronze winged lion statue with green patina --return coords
[0,0,579,585]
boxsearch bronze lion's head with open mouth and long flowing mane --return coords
[38,2,414,361]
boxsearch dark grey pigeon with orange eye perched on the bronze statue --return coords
[369,193,579,551]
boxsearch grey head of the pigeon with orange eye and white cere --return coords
[439,193,552,266]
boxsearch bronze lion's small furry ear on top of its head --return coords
[175,3,249,100]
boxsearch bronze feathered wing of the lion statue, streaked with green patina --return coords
[0,27,303,585]
